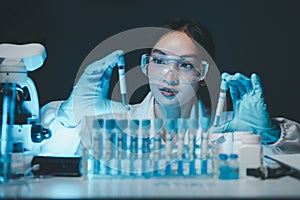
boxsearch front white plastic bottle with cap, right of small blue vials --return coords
[239,134,262,178]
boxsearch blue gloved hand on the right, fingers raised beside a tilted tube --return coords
[210,73,280,143]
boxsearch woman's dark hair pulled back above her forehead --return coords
[162,18,215,59]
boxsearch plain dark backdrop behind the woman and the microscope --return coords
[0,0,300,121]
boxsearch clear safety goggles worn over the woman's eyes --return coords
[141,54,209,83]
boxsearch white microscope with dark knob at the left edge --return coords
[0,43,51,154]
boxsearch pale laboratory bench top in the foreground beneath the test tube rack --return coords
[0,176,300,199]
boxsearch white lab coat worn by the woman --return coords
[41,92,300,155]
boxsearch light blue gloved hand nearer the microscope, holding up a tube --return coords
[57,50,127,127]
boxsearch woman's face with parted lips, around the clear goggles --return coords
[148,32,200,107]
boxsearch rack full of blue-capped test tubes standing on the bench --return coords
[87,115,220,178]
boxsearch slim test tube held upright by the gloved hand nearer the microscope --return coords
[118,56,129,110]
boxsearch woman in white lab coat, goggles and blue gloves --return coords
[41,19,300,154]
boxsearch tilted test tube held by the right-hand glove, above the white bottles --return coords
[214,78,228,126]
